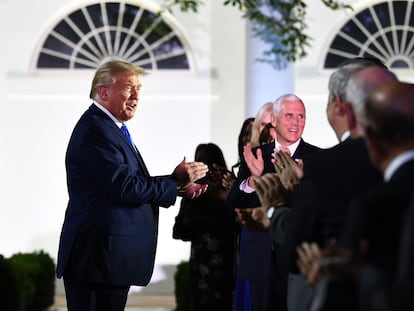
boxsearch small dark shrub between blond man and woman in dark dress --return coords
[174,261,190,311]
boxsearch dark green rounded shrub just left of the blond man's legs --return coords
[8,251,55,311]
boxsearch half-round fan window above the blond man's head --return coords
[33,1,192,70]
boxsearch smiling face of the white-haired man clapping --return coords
[276,99,306,147]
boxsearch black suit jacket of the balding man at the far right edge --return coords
[343,159,414,311]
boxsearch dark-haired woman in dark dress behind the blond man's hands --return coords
[173,143,234,311]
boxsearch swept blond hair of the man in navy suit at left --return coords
[89,60,147,99]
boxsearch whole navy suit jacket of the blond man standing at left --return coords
[57,105,177,286]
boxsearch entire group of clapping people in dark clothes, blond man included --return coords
[57,58,414,311]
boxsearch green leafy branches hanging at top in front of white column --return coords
[162,0,352,69]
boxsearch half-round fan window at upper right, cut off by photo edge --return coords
[323,0,414,70]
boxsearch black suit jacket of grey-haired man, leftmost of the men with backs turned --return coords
[285,138,382,273]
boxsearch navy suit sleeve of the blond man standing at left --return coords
[67,117,177,207]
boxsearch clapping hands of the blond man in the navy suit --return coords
[172,157,208,199]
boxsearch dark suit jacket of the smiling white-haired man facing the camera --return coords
[227,139,320,282]
